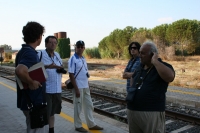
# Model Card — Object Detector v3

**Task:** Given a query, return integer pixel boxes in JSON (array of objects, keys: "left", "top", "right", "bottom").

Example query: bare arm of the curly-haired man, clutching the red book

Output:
[{"left": 15, "top": 64, "right": 42, "bottom": 90}]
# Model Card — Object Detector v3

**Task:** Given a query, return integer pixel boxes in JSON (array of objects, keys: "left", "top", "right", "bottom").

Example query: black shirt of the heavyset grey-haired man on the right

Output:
[{"left": 127, "top": 60, "right": 174, "bottom": 111}]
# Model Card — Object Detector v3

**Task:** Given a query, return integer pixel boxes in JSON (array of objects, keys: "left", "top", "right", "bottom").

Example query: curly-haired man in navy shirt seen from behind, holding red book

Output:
[{"left": 15, "top": 22, "right": 48, "bottom": 133}]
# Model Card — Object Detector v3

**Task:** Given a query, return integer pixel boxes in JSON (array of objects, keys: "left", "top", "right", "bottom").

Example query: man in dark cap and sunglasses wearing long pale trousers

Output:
[{"left": 68, "top": 40, "right": 103, "bottom": 132}]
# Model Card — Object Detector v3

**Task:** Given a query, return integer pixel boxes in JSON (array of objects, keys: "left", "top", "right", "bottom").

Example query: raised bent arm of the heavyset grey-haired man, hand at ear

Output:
[{"left": 151, "top": 53, "right": 175, "bottom": 82}]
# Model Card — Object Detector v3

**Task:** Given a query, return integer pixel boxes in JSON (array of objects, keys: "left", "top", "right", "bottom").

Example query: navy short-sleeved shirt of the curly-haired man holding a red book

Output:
[{"left": 15, "top": 44, "right": 46, "bottom": 110}]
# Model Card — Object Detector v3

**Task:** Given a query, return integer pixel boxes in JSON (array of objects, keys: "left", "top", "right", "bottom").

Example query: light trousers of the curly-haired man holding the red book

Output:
[{"left": 23, "top": 111, "right": 49, "bottom": 133}]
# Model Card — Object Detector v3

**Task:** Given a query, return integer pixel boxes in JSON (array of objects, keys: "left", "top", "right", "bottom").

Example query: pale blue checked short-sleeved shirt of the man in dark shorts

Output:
[{"left": 38, "top": 50, "right": 62, "bottom": 94}]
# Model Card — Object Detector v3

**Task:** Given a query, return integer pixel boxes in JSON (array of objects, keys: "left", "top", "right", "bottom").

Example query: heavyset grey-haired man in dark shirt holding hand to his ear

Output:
[{"left": 127, "top": 42, "right": 175, "bottom": 133}]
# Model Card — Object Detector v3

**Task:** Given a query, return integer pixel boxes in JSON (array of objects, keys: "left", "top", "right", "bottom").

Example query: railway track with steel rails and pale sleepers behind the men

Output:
[{"left": 0, "top": 67, "right": 200, "bottom": 133}]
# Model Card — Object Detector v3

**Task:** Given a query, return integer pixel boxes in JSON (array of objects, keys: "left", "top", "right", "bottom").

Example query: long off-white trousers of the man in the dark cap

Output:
[{"left": 73, "top": 88, "right": 96, "bottom": 128}]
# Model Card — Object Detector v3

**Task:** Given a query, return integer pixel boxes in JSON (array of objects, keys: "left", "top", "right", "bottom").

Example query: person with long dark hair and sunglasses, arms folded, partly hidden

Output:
[{"left": 122, "top": 42, "right": 140, "bottom": 93}]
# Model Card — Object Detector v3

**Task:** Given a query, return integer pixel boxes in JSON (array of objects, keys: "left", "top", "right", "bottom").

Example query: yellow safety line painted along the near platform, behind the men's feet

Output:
[{"left": 0, "top": 82, "right": 102, "bottom": 133}]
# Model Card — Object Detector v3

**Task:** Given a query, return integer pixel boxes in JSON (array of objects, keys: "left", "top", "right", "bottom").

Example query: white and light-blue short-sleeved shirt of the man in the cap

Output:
[{"left": 68, "top": 53, "right": 89, "bottom": 89}]
